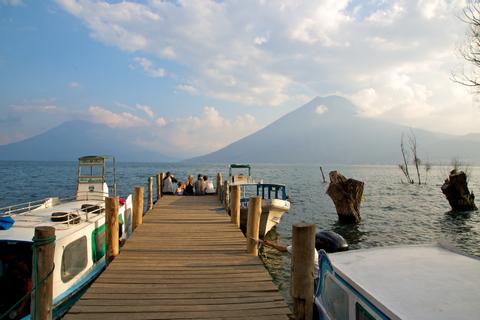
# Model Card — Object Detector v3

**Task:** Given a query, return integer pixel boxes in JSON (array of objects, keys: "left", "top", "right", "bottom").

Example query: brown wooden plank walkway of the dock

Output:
[{"left": 64, "top": 196, "right": 291, "bottom": 320}]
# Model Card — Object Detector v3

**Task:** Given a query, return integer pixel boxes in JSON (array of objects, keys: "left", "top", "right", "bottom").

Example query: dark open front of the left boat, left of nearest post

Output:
[{"left": 0, "top": 241, "right": 32, "bottom": 319}]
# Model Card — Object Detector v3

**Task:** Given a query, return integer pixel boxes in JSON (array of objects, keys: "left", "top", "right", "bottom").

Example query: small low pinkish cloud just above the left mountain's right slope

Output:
[{"left": 88, "top": 106, "right": 148, "bottom": 128}]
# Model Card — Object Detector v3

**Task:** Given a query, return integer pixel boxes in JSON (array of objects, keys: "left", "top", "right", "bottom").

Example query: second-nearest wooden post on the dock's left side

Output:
[{"left": 105, "top": 197, "right": 119, "bottom": 263}]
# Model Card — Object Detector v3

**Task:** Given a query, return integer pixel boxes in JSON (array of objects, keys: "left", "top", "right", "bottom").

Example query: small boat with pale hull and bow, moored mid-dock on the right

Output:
[{"left": 236, "top": 183, "right": 290, "bottom": 238}]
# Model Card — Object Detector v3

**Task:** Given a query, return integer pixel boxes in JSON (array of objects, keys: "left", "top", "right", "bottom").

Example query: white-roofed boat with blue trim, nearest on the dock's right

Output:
[{"left": 314, "top": 244, "right": 480, "bottom": 320}]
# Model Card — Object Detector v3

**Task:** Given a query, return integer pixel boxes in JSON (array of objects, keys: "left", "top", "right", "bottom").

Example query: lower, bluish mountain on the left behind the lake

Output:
[{"left": 0, "top": 120, "right": 174, "bottom": 162}]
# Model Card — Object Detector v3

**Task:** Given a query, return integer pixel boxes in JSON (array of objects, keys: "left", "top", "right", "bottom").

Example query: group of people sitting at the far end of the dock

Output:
[{"left": 162, "top": 172, "right": 215, "bottom": 196}]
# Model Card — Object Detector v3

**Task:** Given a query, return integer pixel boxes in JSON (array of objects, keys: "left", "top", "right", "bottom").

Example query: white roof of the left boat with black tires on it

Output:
[{"left": 0, "top": 200, "right": 104, "bottom": 242}]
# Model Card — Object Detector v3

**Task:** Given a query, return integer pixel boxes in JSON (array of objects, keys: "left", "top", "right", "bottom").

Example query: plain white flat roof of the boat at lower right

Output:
[{"left": 329, "top": 245, "right": 480, "bottom": 319}]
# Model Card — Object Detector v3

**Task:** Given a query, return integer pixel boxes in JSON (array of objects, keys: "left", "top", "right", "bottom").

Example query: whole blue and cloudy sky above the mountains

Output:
[{"left": 0, "top": 0, "right": 480, "bottom": 157}]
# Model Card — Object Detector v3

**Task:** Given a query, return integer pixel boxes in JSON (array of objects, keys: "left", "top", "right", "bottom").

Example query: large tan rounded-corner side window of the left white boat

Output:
[{"left": 62, "top": 236, "right": 88, "bottom": 282}]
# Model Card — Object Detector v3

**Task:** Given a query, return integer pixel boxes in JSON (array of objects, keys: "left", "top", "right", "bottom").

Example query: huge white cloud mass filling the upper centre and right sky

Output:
[{"left": 57, "top": 0, "right": 478, "bottom": 133}]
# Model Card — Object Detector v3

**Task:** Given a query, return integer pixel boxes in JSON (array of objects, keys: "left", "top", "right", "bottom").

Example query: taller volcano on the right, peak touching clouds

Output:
[{"left": 189, "top": 96, "right": 480, "bottom": 164}]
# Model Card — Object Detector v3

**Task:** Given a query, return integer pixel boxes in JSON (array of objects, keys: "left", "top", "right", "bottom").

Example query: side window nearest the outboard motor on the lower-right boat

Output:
[{"left": 321, "top": 274, "right": 348, "bottom": 320}]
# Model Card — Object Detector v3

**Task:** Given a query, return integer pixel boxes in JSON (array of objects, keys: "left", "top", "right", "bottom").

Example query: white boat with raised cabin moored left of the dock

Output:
[{"left": 0, "top": 156, "right": 132, "bottom": 319}]
